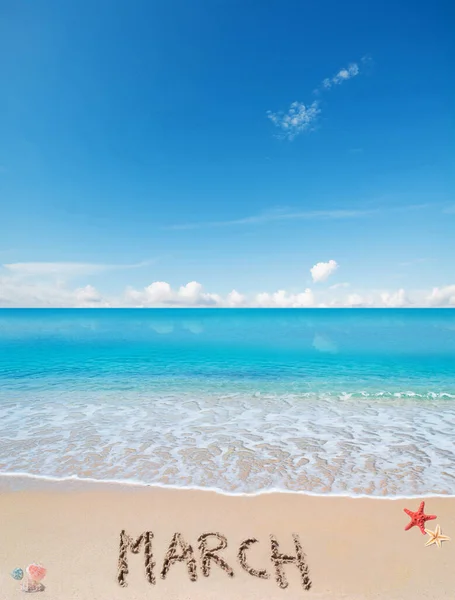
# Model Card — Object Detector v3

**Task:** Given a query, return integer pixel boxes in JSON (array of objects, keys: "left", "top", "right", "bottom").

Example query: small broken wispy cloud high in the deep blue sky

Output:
[{"left": 267, "top": 57, "right": 366, "bottom": 141}]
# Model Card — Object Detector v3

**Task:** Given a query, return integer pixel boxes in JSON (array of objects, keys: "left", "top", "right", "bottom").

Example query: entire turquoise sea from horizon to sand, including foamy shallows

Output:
[{"left": 0, "top": 309, "right": 455, "bottom": 497}]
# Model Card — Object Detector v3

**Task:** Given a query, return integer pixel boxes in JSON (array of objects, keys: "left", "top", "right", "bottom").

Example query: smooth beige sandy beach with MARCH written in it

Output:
[{"left": 0, "top": 478, "right": 455, "bottom": 600}]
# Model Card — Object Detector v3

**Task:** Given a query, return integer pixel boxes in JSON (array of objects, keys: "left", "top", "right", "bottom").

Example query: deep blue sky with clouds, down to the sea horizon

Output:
[{"left": 0, "top": 0, "right": 455, "bottom": 306}]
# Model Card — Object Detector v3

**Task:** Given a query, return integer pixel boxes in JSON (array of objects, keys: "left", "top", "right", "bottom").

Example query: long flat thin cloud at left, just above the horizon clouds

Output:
[{"left": 3, "top": 260, "right": 154, "bottom": 278}]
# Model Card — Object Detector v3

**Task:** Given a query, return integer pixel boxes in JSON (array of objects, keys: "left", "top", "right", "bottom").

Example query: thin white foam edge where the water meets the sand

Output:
[{"left": 0, "top": 472, "right": 455, "bottom": 501}]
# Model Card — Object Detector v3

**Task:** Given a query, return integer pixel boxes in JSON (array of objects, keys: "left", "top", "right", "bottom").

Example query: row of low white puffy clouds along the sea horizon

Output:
[{"left": 0, "top": 261, "right": 455, "bottom": 308}]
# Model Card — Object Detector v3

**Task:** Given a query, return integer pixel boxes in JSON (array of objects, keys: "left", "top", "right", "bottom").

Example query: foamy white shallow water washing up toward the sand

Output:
[{"left": 0, "top": 390, "right": 455, "bottom": 497}]
